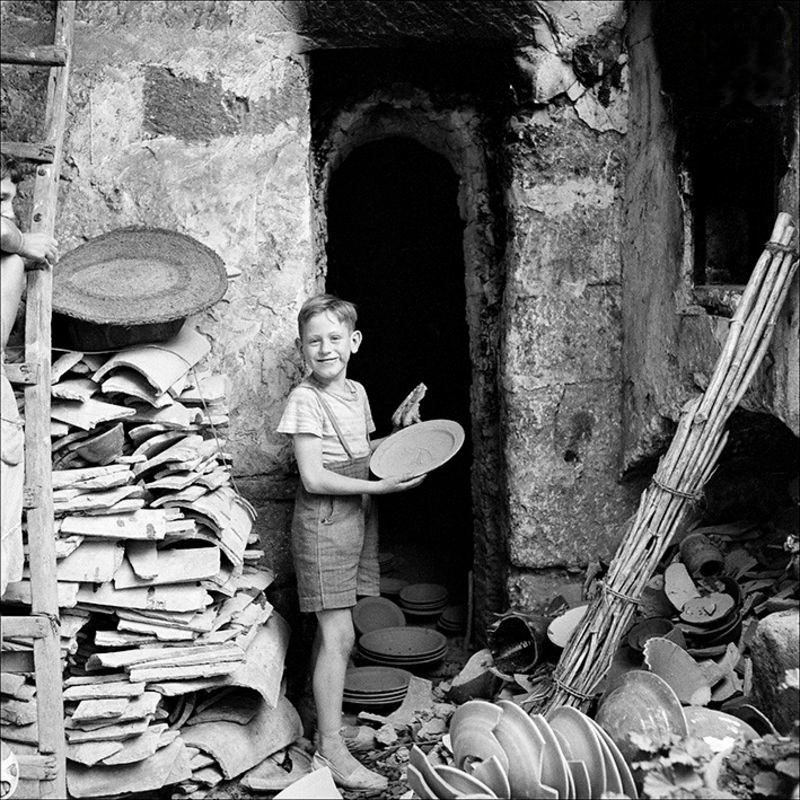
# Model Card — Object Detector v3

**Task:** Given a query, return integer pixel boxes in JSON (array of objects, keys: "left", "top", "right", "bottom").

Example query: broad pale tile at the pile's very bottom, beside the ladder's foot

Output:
[{"left": 67, "top": 738, "right": 192, "bottom": 797}]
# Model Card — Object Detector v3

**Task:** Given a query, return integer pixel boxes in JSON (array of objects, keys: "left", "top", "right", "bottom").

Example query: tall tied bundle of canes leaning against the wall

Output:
[{"left": 545, "top": 214, "right": 797, "bottom": 709}]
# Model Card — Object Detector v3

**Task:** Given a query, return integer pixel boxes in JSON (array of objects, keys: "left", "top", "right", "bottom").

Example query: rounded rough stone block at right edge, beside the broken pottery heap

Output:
[{"left": 750, "top": 610, "right": 800, "bottom": 733}]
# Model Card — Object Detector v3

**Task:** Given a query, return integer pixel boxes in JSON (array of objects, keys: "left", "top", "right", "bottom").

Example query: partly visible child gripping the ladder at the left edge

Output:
[{"left": 0, "top": 154, "right": 58, "bottom": 595}]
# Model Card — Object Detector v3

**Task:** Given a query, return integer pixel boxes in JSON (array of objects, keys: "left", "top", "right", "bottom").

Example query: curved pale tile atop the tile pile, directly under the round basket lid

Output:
[{"left": 92, "top": 325, "right": 211, "bottom": 394}]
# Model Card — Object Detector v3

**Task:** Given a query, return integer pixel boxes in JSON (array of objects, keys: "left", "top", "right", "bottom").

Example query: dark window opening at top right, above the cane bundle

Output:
[{"left": 654, "top": 0, "right": 798, "bottom": 285}]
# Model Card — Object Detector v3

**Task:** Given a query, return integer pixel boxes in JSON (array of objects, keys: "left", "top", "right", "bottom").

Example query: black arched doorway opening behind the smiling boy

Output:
[{"left": 327, "top": 137, "right": 472, "bottom": 602}]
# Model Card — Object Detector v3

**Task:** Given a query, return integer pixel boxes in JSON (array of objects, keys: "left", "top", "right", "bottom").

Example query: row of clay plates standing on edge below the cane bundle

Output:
[{"left": 440, "top": 700, "right": 638, "bottom": 800}]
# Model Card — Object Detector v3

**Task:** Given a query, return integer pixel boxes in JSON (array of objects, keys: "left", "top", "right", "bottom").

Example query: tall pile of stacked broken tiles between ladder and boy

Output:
[{"left": 3, "top": 327, "right": 300, "bottom": 797}]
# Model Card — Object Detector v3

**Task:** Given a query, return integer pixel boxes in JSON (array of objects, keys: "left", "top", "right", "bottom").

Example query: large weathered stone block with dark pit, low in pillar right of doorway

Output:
[{"left": 506, "top": 381, "right": 638, "bottom": 568}]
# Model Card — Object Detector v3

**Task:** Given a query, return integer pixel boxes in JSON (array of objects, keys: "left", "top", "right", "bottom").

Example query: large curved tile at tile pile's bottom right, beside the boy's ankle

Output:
[{"left": 181, "top": 697, "right": 303, "bottom": 779}]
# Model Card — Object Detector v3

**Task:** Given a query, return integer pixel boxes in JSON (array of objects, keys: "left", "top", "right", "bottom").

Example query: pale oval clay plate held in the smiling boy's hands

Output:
[{"left": 369, "top": 419, "right": 464, "bottom": 478}]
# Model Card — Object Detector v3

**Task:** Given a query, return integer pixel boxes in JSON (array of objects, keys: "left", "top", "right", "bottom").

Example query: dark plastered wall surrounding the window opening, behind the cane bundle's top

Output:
[{"left": 622, "top": 2, "right": 800, "bottom": 467}]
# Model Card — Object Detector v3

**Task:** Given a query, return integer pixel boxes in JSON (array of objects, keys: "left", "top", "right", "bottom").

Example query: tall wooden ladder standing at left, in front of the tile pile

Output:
[{"left": 0, "top": 0, "right": 75, "bottom": 798}]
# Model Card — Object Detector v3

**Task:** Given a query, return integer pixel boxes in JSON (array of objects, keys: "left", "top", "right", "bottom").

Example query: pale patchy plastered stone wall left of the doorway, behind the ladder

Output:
[{"left": 2, "top": 0, "right": 313, "bottom": 588}]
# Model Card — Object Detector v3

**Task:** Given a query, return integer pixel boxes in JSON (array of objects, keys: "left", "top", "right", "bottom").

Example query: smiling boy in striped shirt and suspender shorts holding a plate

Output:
[{"left": 278, "top": 294, "right": 424, "bottom": 791}]
